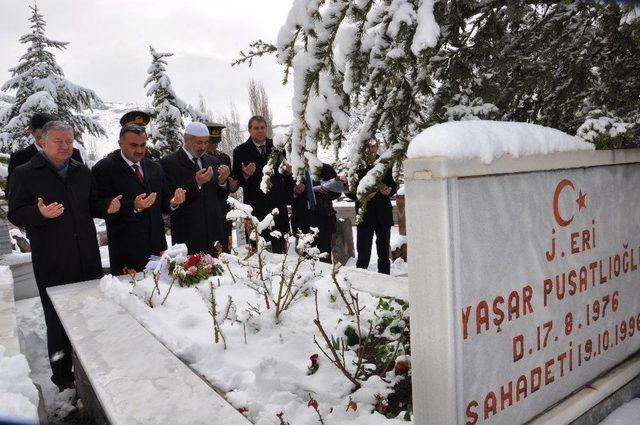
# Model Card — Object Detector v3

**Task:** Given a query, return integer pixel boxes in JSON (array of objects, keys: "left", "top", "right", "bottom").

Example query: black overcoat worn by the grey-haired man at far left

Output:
[{"left": 8, "top": 155, "right": 105, "bottom": 287}]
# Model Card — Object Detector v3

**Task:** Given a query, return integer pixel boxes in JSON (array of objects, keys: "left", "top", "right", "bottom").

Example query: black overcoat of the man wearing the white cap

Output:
[{"left": 160, "top": 148, "right": 228, "bottom": 255}]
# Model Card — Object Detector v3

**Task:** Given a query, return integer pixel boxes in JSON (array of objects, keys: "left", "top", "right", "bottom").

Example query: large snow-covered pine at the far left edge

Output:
[{"left": 0, "top": 4, "right": 106, "bottom": 152}]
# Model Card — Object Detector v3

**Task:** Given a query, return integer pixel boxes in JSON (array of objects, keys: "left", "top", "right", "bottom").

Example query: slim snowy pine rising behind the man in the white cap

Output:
[{"left": 144, "top": 46, "right": 207, "bottom": 155}]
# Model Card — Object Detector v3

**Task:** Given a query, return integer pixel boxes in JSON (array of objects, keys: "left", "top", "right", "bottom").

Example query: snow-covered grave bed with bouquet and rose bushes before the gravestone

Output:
[{"left": 49, "top": 230, "right": 411, "bottom": 424}]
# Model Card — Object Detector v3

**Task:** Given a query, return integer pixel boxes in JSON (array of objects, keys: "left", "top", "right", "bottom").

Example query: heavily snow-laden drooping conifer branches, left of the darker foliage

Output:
[{"left": 277, "top": 0, "right": 439, "bottom": 215}]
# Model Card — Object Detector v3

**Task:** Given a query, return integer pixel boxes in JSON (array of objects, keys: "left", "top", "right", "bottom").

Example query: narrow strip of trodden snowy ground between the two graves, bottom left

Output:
[{"left": 15, "top": 297, "right": 77, "bottom": 425}]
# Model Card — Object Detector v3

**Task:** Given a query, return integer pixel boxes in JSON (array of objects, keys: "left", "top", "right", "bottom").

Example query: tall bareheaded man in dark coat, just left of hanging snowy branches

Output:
[{"left": 232, "top": 116, "right": 293, "bottom": 253}]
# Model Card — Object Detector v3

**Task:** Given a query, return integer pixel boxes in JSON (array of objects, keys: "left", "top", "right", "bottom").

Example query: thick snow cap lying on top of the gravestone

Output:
[{"left": 407, "top": 120, "right": 595, "bottom": 164}]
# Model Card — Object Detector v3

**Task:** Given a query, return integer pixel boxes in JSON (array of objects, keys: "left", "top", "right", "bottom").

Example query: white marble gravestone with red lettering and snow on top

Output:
[{"left": 405, "top": 121, "right": 640, "bottom": 424}]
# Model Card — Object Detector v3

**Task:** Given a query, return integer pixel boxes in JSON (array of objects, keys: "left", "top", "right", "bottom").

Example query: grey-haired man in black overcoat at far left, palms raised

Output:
[{"left": 8, "top": 121, "right": 120, "bottom": 390}]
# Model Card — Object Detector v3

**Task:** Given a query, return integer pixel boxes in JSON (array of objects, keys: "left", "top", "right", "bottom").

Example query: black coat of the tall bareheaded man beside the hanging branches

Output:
[{"left": 231, "top": 139, "right": 294, "bottom": 234}]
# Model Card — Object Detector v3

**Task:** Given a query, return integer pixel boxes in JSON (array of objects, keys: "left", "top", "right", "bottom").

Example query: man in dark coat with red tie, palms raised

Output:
[{"left": 91, "top": 124, "right": 185, "bottom": 275}]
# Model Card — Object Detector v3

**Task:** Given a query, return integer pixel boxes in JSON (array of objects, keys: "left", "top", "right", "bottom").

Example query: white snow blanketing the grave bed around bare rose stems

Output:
[{"left": 100, "top": 245, "right": 410, "bottom": 425}]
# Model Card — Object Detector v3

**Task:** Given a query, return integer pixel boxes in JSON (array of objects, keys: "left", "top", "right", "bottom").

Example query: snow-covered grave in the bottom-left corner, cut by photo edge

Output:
[{"left": 0, "top": 266, "right": 39, "bottom": 423}]
